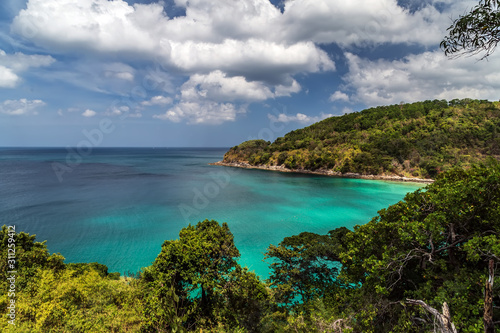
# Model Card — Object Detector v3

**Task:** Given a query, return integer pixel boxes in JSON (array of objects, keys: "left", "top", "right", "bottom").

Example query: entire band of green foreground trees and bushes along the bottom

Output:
[{"left": 0, "top": 160, "right": 500, "bottom": 333}]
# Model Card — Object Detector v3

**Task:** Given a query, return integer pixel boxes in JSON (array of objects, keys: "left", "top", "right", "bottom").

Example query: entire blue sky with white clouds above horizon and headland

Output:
[{"left": 0, "top": 0, "right": 500, "bottom": 147}]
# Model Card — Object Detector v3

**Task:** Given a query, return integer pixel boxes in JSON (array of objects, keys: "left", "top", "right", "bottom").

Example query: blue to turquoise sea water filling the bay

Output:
[{"left": 0, "top": 148, "right": 422, "bottom": 278}]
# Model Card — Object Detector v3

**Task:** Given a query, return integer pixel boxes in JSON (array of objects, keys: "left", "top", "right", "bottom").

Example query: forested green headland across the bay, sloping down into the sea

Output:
[{"left": 223, "top": 99, "right": 500, "bottom": 178}]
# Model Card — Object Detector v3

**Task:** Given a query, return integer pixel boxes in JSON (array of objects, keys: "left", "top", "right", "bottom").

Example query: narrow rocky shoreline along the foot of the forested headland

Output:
[{"left": 209, "top": 161, "right": 434, "bottom": 184}]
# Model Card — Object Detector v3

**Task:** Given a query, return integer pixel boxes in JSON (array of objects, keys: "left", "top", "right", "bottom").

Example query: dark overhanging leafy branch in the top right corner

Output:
[{"left": 441, "top": 0, "right": 500, "bottom": 59}]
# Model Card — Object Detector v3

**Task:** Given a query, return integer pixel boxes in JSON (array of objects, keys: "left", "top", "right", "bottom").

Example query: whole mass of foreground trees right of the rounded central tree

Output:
[{"left": 267, "top": 161, "right": 500, "bottom": 333}]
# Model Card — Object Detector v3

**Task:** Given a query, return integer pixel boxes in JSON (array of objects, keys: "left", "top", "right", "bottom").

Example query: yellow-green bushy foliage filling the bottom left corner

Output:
[{"left": 0, "top": 226, "right": 142, "bottom": 333}]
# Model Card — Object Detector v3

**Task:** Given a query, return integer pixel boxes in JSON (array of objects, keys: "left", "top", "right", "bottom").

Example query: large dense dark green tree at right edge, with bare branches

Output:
[{"left": 340, "top": 161, "right": 500, "bottom": 332}]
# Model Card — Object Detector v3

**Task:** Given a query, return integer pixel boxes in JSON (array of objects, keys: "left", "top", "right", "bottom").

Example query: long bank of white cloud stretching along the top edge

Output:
[{"left": 6, "top": 0, "right": 464, "bottom": 82}]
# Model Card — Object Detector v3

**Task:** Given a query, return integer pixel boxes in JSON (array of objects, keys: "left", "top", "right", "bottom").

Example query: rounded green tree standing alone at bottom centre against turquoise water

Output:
[{"left": 141, "top": 220, "right": 268, "bottom": 332}]
